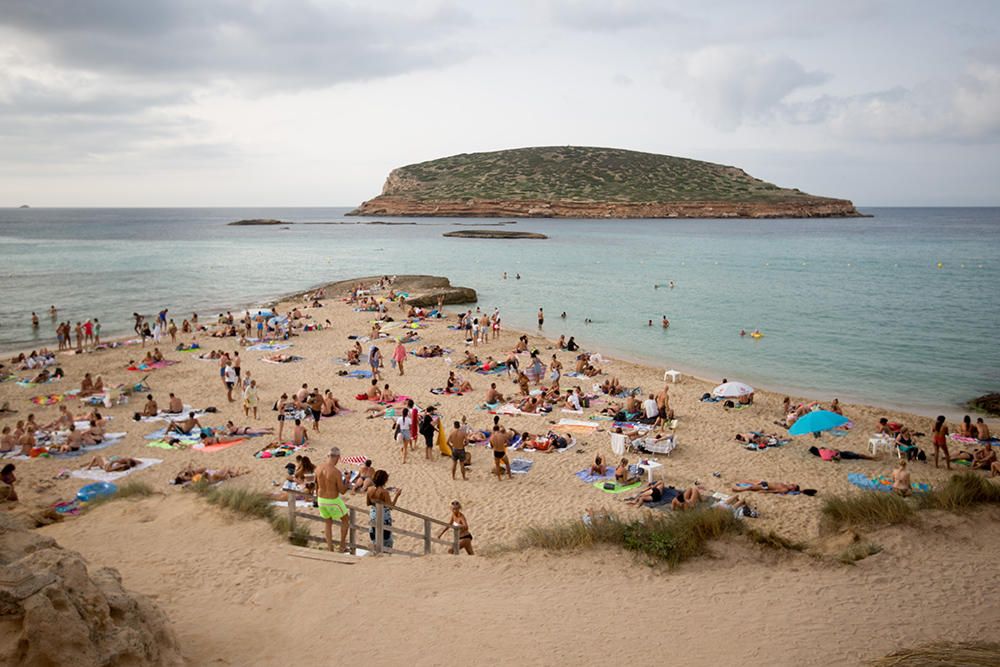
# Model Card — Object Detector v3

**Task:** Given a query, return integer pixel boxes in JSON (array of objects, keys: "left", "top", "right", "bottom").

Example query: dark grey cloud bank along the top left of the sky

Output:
[{"left": 0, "top": 0, "right": 468, "bottom": 88}]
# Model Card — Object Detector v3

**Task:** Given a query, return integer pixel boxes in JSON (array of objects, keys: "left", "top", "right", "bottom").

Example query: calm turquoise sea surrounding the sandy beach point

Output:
[{"left": 0, "top": 208, "right": 1000, "bottom": 411}]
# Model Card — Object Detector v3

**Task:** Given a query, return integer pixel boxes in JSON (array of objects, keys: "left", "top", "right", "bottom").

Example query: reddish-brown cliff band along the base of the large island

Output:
[{"left": 349, "top": 196, "right": 861, "bottom": 218}]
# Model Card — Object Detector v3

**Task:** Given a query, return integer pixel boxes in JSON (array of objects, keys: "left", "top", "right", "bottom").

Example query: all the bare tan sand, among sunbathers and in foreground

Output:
[{"left": 0, "top": 276, "right": 1000, "bottom": 664}]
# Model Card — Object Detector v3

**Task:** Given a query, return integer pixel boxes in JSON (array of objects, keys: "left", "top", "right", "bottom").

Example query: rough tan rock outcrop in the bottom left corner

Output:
[{"left": 0, "top": 514, "right": 184, "bottom": 667}]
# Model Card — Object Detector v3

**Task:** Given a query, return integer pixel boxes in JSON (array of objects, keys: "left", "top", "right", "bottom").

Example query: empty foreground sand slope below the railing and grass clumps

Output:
[{"left": 43, "top": 496, "right": 1000, "bottom": 665}]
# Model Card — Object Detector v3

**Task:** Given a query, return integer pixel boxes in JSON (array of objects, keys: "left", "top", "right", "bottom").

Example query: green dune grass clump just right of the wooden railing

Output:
[{"left": 518, "top": 509, "right": 743, "bottom": 567}]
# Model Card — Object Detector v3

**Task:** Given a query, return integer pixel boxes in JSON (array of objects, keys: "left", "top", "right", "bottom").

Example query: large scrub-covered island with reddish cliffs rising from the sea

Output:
[{"left": 348, "top": 146, "right": 861, "bottom": 218}]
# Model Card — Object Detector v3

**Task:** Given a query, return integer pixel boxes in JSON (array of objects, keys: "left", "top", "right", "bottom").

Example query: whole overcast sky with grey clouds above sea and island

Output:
[{"left": 0, "top": 0, "right": 1000, "bottom": 206}]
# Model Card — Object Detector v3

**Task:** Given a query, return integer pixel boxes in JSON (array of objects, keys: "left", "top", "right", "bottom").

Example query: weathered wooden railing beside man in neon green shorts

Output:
[{"left": 284, "top": 489, "right": 460, "bottom": 556}]
